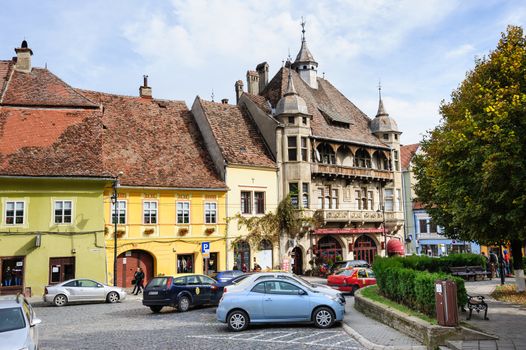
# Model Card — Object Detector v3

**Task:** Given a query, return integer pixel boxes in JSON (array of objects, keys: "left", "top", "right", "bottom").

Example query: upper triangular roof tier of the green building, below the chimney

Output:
[{"left": 0, "top": 68, "right": 99, "bottom": 108}]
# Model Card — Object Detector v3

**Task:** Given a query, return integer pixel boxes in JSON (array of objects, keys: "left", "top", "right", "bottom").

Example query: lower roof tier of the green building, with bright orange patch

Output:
[{"left": 0, "top": 106, "right": 104, "bottom": 176}]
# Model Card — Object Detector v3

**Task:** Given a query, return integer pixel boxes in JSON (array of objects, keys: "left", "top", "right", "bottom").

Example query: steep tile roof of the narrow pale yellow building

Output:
[{"left": 198, "top": 98, "right": 276, "bottom": 167}]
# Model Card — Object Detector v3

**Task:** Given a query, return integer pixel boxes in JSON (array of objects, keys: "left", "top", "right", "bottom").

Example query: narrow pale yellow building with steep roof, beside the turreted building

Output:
[{"left": 192, "top": 97, "right": 280, "bottom": 270}]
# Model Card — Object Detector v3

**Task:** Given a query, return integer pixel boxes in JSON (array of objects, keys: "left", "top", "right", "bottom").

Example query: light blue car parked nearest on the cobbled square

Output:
[{"left": 216, "top": 278, "right": 345, "bottom": 332}]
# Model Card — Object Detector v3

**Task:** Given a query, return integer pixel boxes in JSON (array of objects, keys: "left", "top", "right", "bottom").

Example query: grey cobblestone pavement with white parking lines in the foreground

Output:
[{"left": 35, "top": 296, "right": 364, "bottom": 350}]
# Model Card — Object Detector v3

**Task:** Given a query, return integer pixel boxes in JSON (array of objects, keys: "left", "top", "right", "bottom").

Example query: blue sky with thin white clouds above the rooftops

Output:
[{"left": 0, "top": 0, "right": 526, "bottom": 144}]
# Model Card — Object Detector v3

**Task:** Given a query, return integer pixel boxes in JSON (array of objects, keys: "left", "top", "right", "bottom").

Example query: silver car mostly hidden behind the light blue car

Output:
[{"left": 217, "top": 272, "right": 345, "bottom": 304}]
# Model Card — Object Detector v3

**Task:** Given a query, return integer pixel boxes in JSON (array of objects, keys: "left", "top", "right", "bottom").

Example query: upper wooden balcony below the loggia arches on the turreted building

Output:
[{"left": 311, "top": 163, "right": 394, "bottom": 182}]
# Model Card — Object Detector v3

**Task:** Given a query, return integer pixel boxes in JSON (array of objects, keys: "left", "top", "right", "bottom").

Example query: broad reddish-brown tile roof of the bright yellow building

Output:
[{"left": 78, "top": 90, "right": 226, "bottom": 189}]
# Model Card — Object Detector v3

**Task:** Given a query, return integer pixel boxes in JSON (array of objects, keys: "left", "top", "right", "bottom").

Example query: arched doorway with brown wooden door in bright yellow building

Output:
[{"left": 117, "top": 249, "right": 154, "bottom": 288}]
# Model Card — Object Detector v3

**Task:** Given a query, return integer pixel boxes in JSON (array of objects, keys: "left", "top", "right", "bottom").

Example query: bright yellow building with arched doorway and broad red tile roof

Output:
[{"left": 81, "top": 88, "right": 227, "bottom": 287}]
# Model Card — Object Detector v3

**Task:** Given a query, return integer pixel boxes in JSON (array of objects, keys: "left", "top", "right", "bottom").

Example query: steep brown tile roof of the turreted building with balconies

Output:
[{"left": 261, "top": 68, "right": 387, "bottom": 148}]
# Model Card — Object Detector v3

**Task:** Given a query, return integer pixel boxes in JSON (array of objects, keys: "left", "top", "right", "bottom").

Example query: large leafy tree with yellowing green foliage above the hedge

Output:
[{"left": 414, "top": 26, "right": 526, "bottom": 291}]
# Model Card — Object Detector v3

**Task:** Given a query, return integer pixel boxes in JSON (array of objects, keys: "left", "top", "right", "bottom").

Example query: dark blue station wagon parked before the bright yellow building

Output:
[{"left": 142, "top": 274, "right": 219, "bottom": 313}]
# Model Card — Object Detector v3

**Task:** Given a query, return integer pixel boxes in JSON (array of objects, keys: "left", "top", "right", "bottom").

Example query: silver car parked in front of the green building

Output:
[{"left": 44, "top": 278, "right": 126, "bottom": 306}]
